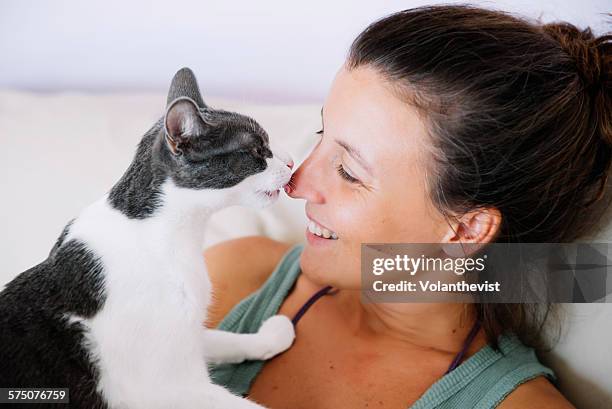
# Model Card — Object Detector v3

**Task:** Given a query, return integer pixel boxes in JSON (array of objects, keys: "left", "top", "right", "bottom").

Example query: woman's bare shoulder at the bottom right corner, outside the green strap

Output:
[{"left": 498, "top": 376, "right": 576, "bottom": 409}]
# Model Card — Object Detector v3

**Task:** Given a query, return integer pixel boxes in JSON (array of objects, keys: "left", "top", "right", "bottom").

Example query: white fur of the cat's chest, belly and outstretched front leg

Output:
[{"left": 65, "top": 182, "right": 295, "bottom": 409}]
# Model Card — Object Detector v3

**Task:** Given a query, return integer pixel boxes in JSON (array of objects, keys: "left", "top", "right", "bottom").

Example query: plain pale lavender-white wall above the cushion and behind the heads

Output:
[{"left": 0, "top": 0, "right": 612, "bottom": 102}]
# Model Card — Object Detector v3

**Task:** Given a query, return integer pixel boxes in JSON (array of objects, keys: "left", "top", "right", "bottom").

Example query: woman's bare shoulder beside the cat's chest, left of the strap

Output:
[{"left": 204, "top": 236, "right": 291, "bottom": 328}]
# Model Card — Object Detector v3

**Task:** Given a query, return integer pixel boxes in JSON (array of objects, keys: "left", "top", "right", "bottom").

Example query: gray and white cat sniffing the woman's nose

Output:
[{"left": 0, "top": 68, "right": 295, "bottom": 409}]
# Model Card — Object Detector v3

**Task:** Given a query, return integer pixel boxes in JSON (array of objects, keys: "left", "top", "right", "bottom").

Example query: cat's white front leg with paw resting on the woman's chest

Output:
[{"left": 204, "top": 315, "right": 295, "bottom": 364}]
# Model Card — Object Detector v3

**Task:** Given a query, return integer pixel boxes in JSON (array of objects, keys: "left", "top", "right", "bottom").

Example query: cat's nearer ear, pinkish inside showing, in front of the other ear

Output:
[{"left": 164, "top": 97, "right": 206, "bottom": 155}]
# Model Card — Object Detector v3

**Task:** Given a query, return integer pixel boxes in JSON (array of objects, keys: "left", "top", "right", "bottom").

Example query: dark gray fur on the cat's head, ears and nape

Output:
[{"left": 109, "top": 68, "right": 272, "bottom": 218}]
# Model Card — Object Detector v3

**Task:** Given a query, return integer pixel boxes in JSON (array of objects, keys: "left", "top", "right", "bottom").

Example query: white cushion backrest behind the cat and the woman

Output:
[{"left": 0, "top": 91, "right": 612, "bottom": 409}]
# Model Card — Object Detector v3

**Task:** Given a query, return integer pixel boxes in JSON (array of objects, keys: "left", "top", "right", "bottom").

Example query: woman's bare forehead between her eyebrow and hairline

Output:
[{"left": 322, "top": 67, "right": 427, "bottom": 166}]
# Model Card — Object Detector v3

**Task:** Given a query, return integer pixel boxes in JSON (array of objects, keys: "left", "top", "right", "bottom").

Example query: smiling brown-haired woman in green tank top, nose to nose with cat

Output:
[{"left": 206, "top": 6, "right": 612, "bottom": 409}]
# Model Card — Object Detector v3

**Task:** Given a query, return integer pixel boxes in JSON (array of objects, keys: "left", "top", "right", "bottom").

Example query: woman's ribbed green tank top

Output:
[{"left": 209, "top": 244, "right": 556, "bottom": 409}]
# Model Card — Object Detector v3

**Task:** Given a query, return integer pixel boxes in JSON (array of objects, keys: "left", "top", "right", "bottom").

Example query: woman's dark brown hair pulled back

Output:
[{"left": 347, "top": 5, "right": 612, "bottom": 347}]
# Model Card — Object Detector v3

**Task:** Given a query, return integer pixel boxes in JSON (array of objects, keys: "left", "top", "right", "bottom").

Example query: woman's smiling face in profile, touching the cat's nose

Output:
[{"left": 289, "top": 67, "right": 449, "bottom": 289}]
